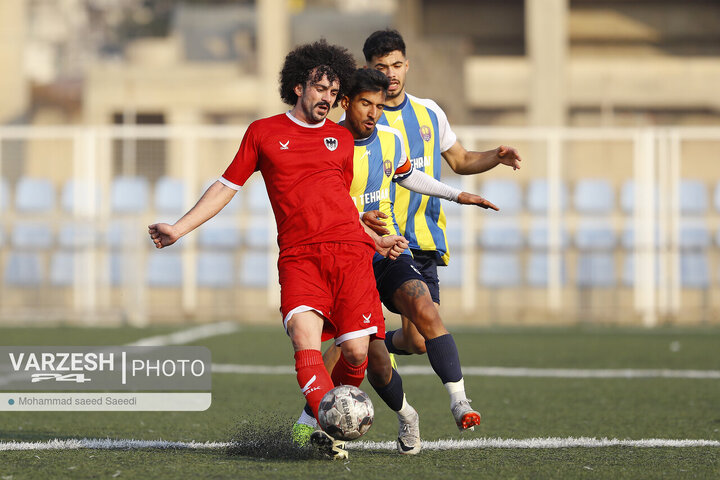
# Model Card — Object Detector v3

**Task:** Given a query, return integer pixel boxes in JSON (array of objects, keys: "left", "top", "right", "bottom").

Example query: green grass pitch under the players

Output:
[{"left": 0, "top": 326, "right": 720, "bottom": 480}]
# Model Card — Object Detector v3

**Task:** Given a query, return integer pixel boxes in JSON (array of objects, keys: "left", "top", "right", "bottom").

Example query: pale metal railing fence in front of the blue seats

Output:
[{"left": 0, "top": 126, "right": 720, "bottom": 326}]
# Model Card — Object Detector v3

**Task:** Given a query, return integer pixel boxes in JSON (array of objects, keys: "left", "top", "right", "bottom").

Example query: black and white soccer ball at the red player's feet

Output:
[{"left": 318, "top": 385, "right": 375, "bottom": 440}]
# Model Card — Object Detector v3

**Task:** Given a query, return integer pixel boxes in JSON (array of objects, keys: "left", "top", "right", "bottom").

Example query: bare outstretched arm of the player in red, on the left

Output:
[{"left": 148, "top": 181, "right": 237, "bottom": 248}]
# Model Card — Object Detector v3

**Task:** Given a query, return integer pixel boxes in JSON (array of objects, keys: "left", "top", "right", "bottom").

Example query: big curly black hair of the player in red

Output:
[{"left": 280, "top": 38, "right": 356, "bottom": 107}]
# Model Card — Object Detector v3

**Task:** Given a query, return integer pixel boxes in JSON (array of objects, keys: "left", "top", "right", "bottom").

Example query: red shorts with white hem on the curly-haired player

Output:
[{"left": 278, "top": 242, "right": 385, "bottom": 345}]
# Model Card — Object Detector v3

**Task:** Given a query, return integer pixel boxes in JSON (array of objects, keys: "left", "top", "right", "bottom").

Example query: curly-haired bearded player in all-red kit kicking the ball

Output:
[{"left": 148, "top": 40, "right": 408, "bottom": 457}]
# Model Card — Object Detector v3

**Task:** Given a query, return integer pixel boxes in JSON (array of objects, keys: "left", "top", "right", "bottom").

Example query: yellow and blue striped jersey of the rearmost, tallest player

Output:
[{"left": 380, "top": 93, "right": 457, "bottom": 265}]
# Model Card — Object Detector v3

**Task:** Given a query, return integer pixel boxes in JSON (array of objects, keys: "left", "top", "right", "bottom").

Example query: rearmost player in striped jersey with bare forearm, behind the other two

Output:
[{"left": 363, "top": 30, "right": 521, "bottom": 431}]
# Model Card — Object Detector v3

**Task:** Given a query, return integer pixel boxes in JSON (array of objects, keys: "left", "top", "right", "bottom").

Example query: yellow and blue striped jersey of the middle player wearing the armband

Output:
[{"left": 350, "top": 125, "right": 412, "bottom": 253}]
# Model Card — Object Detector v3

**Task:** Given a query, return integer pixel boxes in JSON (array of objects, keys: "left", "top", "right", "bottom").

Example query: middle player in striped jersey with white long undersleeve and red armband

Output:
[{"left": 340, "top": 69, "right": 497, "bottom": 436}]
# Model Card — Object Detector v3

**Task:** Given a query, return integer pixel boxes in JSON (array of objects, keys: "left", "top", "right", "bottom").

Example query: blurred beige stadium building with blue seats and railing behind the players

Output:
[{"left": 0, "top": 0, "right": 720, "bottom": 325}]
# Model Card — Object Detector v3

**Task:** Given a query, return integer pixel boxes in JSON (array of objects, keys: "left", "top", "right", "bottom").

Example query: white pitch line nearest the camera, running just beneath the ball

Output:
[{"left": 0, "top": 437, "right": 720, "bottom": 451}]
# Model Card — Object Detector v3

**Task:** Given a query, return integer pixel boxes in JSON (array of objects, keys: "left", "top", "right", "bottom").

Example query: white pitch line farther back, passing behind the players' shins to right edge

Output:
[{"left": 212, "top": 364, "right": 720, "bottom": 379}]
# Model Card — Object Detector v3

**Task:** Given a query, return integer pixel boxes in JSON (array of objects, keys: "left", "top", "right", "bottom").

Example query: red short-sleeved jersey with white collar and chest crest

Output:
[{"left": 220, "top": 112, "right": 374, "bottom": 251}]
